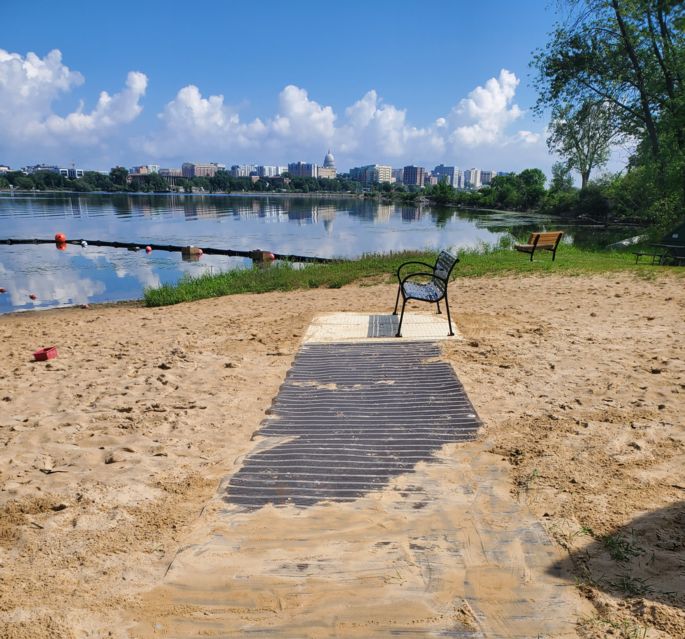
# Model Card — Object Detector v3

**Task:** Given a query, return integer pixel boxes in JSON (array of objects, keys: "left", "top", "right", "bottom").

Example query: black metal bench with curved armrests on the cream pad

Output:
[{"left": 392, "top": 251, "right": 459, "bottom": 337}]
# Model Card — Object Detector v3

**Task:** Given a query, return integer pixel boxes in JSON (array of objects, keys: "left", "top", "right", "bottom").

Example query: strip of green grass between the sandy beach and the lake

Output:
[{"left": 145, "top": 245, "right": 685, "bottom": 306}]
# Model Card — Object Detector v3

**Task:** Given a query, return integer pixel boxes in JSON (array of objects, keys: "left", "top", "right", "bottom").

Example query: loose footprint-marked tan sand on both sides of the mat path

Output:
[{"left": 0, "top": 275, "right": 685, "bottom": 637}]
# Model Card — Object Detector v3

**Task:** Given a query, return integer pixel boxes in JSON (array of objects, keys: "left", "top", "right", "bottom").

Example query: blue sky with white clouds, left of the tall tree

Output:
[{"left": 0, "top": 0, "right": 584, "bottom": 174}]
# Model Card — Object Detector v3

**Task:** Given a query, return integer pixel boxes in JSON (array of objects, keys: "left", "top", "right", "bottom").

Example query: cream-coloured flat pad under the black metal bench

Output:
[{"left": 303, "top": 312, "right": 462, "bottom": 343}]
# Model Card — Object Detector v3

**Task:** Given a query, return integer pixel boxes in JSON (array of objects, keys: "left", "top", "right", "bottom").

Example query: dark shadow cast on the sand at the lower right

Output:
[{"left": 548, "top": 501, "right": 685, "bottom": 612}]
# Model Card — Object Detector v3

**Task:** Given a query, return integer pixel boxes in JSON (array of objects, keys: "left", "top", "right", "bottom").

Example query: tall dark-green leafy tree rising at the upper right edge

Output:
[{"left": 534, "top": 0, "right": 685, "bottom": 220}]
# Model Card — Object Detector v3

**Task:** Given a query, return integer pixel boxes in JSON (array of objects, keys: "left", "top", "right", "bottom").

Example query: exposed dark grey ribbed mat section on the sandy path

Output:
[{"left": 224, "top": 341, "right": 480, "bottom": 509}]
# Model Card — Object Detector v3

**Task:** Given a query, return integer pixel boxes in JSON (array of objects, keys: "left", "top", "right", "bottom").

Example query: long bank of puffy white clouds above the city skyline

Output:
[{"left": 144, "top": 69, "right": 541, "bottom": 168}]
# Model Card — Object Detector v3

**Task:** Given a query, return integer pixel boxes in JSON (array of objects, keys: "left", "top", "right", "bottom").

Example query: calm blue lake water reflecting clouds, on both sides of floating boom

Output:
[{"left": 0, "top": 194, "right": 620, "bottom": 313}]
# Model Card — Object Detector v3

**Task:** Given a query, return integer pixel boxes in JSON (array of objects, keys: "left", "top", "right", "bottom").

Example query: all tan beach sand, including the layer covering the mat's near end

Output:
[{"left": 0, "top": 274, "right": 685, "bottom": 638}]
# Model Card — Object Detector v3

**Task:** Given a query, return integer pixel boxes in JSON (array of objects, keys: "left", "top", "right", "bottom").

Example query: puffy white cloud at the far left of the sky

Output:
[{"left": 0, "top": 49, "right": 147, "bottom": 146}]
